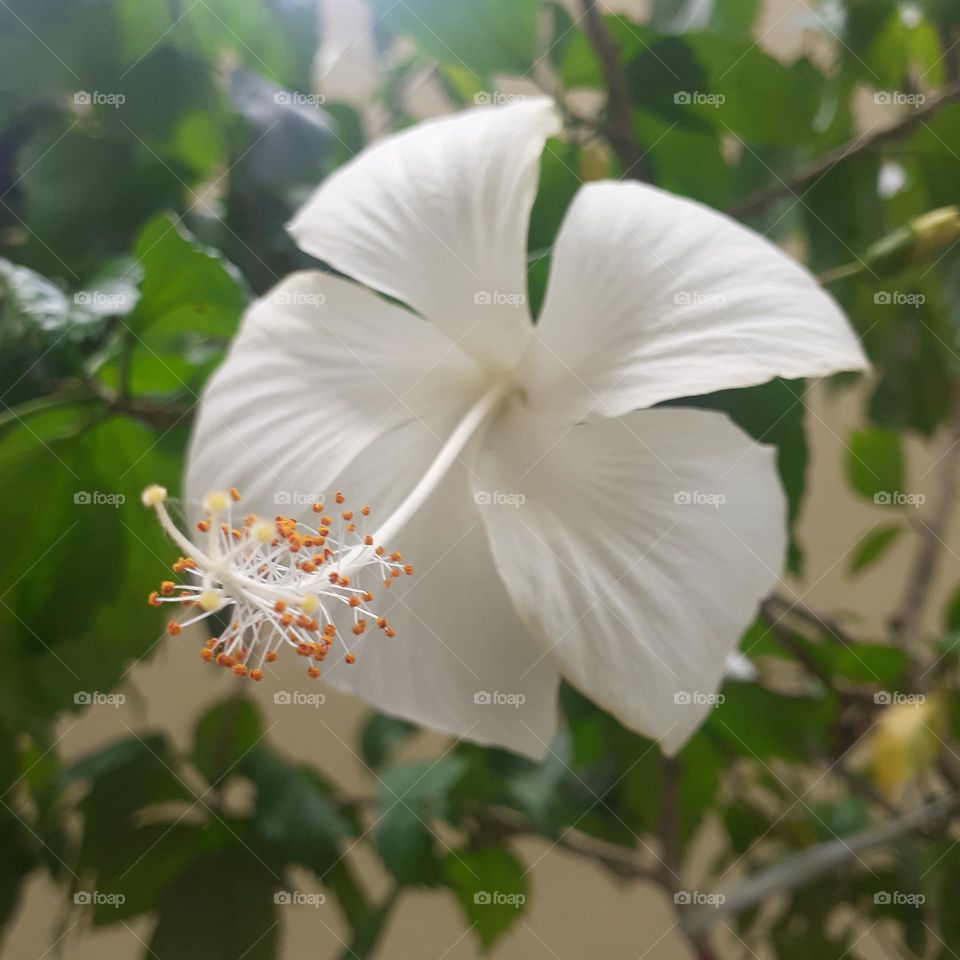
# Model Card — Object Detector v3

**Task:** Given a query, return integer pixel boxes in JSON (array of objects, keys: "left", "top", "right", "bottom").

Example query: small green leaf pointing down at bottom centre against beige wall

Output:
[{"left": 443, "top": 847, "right": 527, "bottom": 950}]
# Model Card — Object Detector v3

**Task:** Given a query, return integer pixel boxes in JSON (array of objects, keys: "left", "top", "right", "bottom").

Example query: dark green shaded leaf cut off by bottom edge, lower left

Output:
[{"left": 148, "top": 849, "right": 279, "bottom": 960}]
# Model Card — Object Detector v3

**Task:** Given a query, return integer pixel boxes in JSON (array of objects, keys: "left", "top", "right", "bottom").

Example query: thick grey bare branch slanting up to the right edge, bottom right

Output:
[{"left": 682, "top": 795, "right": 960, "bottom": 936}]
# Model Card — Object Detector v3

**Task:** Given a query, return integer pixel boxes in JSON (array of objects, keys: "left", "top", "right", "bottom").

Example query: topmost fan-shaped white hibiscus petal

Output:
[{"left": 289, "top": 98, "right": 560, "bottom": 365}]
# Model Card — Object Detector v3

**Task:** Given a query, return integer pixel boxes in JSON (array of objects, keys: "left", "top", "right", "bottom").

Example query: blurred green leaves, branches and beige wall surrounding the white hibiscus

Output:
[{"left": 0, "top": 0, "right": 960, "bottom": 960}]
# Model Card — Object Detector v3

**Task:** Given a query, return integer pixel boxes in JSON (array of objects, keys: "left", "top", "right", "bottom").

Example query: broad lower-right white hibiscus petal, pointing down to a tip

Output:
[{"left": 478, "top": 409, "right": 786, "bottom": 753}]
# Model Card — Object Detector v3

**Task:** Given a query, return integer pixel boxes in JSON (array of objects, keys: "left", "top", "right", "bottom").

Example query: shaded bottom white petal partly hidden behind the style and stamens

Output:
[{"left": 316, "top": 414, "right": 559, "bottom": 759}]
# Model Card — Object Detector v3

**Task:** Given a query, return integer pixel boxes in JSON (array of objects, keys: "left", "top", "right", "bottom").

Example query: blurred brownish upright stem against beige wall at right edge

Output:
[{"left": 890, "top": 399, "right": 960, "bottom": 647}]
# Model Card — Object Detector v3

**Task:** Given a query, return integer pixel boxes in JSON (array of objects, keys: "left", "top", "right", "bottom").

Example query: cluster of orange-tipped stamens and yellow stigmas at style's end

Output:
[{"left": 142, "top": 486, "right": 413, "bottom": 680}]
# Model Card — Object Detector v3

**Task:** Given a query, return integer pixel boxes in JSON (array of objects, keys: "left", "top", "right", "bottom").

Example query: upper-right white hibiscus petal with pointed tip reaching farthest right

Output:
[{"left": 522, "top": 183, "right": 866, "bottom": 423}]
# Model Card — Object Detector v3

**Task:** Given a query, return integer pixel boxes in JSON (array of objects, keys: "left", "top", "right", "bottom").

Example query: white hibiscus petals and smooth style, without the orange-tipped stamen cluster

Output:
[{"left": 186, "top": 99, "right": 866, "bottom": 757}]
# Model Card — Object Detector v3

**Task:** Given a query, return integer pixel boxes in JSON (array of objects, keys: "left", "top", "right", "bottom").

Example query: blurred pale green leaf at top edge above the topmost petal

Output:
[{"left": 373, "top": 0, "right": 537, "bottom": 75}]
